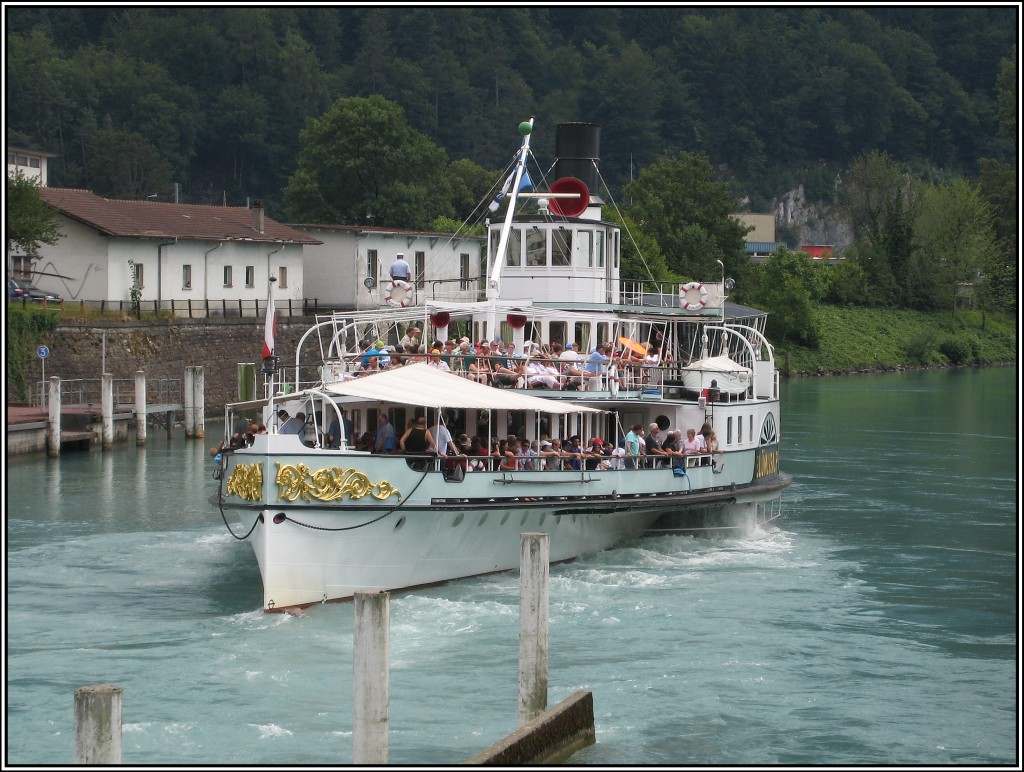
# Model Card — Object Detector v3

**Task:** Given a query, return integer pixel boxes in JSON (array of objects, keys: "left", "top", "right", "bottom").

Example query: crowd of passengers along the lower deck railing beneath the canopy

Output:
[{"left": 395, "top": 416, "right": 719, "bottom": 472}]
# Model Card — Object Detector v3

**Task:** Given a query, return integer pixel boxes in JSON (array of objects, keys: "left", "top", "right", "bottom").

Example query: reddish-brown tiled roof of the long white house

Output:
[{"left": 41, "top": 187, "right": 323, "bottom": 244}]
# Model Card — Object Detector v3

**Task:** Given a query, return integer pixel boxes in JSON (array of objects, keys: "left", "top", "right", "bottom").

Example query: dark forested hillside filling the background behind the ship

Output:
[{"left": 5, "top": 5, "right": 1019, "bottom": 217}]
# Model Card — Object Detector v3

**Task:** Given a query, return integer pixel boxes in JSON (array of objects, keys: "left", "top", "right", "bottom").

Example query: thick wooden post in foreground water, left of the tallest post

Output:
[{"left": 352, "top": 591, "right": 390, "bottom": 764}]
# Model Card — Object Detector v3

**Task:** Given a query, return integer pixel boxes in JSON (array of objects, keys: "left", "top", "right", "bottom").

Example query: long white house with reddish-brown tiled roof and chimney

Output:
[{"left": 29, "top": 187, "right": 321, "bottom": 312}]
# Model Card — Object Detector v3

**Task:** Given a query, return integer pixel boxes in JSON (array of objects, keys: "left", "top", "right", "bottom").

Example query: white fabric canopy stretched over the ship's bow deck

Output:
[{"left": 324, "top": 362, "right": 604, "bottom": 415}]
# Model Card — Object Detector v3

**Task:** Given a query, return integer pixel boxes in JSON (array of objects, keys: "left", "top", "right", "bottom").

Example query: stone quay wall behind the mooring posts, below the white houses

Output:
[{"left": 7, "top": 316, "right": 318, "bottom": 419}]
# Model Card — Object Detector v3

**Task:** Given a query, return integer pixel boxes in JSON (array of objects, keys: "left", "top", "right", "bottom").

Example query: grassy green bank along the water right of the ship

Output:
[{"left": 776, "top": 306, "right": 1017, "bottom": 374}]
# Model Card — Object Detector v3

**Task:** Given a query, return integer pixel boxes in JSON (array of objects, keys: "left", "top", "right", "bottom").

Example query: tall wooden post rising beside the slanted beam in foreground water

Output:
[{"left": 519, "top": 533, "right": 551, "bottom": 726}]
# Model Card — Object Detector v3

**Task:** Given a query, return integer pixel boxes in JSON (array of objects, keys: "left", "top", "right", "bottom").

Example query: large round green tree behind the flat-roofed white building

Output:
[{"left": 285, "top": 96, "right": 452, "bottom": 228}]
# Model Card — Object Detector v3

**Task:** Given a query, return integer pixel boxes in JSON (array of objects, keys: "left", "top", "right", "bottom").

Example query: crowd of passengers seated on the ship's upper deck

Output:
[{"left": 345, "top": 327, "right": 671, "bottom": 390}]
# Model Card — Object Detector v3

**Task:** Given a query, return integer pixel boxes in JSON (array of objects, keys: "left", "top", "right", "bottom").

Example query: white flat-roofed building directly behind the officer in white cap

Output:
[{"left": 292, "top": 224, "right": 486, "bottom": 310}]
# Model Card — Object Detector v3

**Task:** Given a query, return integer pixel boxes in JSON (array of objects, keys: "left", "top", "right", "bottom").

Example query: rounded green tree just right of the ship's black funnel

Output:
[{"left": 625, "top": 153, "right": 746, "bottom": 280}]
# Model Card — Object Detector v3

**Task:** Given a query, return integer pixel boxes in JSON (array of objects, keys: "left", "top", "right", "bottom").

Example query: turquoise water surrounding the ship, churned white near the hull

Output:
[{"left": 5, "top": 369, "right": 1019, "bottom": 766}]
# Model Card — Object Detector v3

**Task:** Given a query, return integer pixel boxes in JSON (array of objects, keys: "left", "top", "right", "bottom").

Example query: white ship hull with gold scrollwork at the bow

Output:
[{"left": 221, "top": 442, "right": 787, "bottom": 611}]
